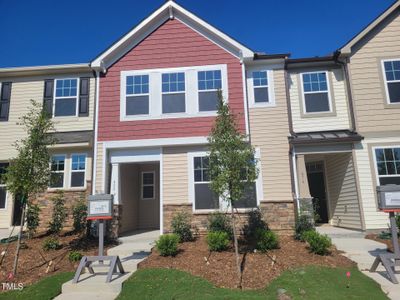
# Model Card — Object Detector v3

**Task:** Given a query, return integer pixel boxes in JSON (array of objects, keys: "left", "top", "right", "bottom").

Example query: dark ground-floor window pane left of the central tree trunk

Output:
[{"left": 193, "top": 157, "right": 219, "bottom": 209}]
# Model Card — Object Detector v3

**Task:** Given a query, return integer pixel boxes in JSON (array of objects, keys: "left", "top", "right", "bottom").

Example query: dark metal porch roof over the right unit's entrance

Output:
[{"left": 289, "top": 130, "right": 364, "bottom": 145}]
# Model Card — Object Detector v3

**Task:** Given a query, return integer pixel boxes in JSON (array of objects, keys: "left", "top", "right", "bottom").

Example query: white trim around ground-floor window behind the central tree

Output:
[{"left": 187, "top": 148, "right": 263, "bottom": 214}]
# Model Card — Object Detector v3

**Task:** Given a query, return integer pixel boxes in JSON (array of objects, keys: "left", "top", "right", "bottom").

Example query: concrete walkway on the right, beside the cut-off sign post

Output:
[{"left": 317, "top": 226, "right": 400, "bottom": 300}]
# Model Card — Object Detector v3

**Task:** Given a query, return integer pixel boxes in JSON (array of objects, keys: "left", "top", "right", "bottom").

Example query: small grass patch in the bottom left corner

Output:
[{"left": 0, "top": 272, "right": 74, "bottom": 300}]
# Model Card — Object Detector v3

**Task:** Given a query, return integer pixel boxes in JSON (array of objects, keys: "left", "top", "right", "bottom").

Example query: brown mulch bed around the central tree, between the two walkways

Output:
[{"left": 139, "top": 236, "right": 355, "bottom": 289}]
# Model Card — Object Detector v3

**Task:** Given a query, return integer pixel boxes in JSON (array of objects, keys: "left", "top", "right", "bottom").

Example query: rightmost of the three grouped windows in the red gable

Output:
[{"left": 197, "top": 70, "right": 222, "bottom": 111}]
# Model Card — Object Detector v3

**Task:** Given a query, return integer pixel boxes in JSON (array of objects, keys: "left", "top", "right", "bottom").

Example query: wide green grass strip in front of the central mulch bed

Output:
[{"left": 118, "top": 266, "right": 388, "bottom": 300}]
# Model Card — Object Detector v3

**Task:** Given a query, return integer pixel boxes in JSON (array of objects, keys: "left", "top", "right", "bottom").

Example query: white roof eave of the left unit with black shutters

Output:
[{"left": 0, "top": 64, "right": 92, "bottom": 77}]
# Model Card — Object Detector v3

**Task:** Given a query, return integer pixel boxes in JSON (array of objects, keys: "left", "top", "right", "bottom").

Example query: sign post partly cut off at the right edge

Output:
[{"left": 370, "top": 184, "right": 400, "bottom": 284}]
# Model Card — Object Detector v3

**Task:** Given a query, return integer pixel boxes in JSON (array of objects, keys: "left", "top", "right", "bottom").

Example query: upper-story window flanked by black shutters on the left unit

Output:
[{"left": 54, "top": 78, "right": 78, "bottom": 117}]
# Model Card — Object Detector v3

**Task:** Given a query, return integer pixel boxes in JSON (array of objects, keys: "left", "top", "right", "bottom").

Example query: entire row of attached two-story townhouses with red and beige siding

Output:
[{"left": 0, "top": 1, "right": 400, "bottom": 235}]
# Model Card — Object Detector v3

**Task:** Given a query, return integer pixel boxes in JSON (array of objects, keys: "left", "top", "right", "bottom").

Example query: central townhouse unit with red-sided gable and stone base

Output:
[{"left": 91, "top": 1, "right": 294, "bottom": 235}]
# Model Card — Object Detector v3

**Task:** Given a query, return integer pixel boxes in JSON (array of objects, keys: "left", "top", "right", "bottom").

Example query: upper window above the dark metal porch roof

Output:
[{"left": 301, "top": 71, "right": 331, "bottom": 113}]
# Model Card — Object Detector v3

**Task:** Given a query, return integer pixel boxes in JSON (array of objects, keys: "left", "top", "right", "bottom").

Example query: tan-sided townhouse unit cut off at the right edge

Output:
[{"left": 339, "top": 1, "right": 400, "bottom": 230}]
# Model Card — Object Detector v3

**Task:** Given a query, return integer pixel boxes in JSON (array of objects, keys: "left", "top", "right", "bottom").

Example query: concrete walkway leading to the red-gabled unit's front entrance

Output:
[{"left": 55, "top": 230, "right": 160, "bottom": 300}]
